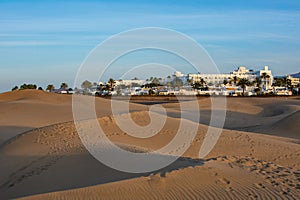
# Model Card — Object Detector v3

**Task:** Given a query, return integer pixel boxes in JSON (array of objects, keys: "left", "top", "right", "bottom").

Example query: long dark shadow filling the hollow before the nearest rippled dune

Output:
[{"left": 0, "top": 152, "right": 204, "bottom": 199}]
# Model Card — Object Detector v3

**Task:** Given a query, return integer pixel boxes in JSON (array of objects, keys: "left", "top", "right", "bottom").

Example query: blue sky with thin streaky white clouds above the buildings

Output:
[{"left": 0, "top": 0, "right": 300, "bottom": 92}]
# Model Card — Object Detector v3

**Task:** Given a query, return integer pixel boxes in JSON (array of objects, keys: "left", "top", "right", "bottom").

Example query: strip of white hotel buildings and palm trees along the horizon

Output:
[{"left": 12, "top": 66, "right": 300, "bottom": 96}]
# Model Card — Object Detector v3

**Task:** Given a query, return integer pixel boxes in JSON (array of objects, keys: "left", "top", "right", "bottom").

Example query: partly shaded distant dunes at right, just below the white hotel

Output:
[{"left": 164, "top": 98, "right": 300, "bottom": 139}]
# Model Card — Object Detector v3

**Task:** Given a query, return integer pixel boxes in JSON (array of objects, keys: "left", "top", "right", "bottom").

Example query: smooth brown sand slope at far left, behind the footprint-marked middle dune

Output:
[{"left": 0, "top": 90, "right": 147, "bottom": 145}]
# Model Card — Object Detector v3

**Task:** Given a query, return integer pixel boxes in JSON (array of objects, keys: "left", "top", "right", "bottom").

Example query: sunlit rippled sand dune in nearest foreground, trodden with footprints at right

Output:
[{"left": 19, "top": 158, "right": 299, "bottom": 199}]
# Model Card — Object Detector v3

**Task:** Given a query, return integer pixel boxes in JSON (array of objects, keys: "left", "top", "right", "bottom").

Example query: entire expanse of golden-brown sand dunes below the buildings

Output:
[{"left": 0, "top": 90, "right": 300, "bottom": 199}]
